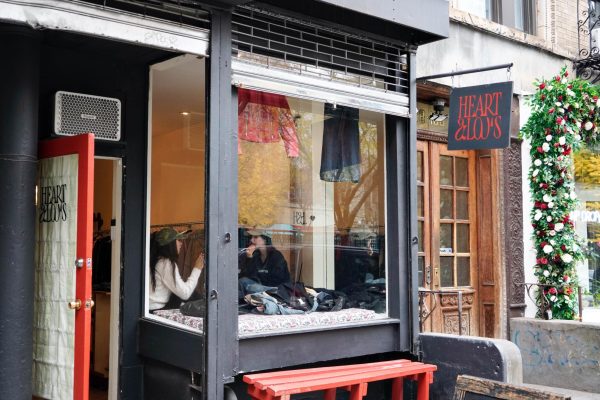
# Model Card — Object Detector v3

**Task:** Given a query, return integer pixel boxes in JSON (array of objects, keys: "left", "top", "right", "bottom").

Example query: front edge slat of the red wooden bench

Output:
[{"left": 265, "top": 363, "right": 437, "bottom": 396}]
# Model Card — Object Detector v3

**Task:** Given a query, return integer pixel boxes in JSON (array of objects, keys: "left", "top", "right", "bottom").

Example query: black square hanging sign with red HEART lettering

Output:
[{"left": 448, "top": 82, "right": 513, "bottom": 150}]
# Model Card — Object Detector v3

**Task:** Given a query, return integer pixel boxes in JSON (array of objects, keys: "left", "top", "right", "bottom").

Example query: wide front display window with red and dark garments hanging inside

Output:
[{"left": 238, "top": 88, "right": 387, "bottom": 337}]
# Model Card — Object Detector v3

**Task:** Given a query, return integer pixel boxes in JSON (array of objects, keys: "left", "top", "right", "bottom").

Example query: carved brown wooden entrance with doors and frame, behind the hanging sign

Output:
[{"left": 417, "top": 82, "right": 518, "bottom": 337}]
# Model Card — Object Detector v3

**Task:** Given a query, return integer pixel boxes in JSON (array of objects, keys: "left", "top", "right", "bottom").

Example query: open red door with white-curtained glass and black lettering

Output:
[{"left": 33, "top": 134, "right": 94, "bottom": 400}]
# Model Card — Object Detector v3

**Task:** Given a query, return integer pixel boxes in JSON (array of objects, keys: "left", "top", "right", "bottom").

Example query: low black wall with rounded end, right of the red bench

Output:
[{"left": 419, "top": 333, "right": 523, "bottom": 400}]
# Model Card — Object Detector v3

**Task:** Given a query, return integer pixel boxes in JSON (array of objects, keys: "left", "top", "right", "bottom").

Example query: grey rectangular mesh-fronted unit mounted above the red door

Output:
[{"left": 54, "top": 91, "right": 121, "bottom": 141}]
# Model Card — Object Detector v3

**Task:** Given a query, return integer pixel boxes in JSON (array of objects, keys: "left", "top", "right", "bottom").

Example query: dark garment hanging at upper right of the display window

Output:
[{"left": 320, "top": 103, "right": 360, "bottom": 183}]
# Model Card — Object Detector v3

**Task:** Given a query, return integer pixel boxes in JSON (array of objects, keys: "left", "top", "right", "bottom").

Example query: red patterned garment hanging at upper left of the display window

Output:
[{"left": 238, "top": 89, "right": 300, "bottom": 157}]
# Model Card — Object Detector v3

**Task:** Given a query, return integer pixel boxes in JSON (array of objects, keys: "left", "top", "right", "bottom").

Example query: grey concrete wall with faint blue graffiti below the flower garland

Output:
[{"left": 510, "top": 318, "right": 600, "bottom": 398}]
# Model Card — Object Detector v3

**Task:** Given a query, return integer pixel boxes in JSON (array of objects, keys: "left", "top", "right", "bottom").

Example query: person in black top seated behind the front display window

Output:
[{"left": 238, "top": 229, "right": 290, "bottom": 287}]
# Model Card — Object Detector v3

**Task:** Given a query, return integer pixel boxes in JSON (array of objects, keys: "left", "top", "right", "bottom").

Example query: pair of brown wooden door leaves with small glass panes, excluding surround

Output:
[{"left": 417, "top": 142, "right": 479, "bottom": 335}]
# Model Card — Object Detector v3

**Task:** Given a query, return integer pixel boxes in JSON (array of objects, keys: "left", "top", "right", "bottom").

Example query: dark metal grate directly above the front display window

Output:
[{"left": 233, "top": 6, "right": 408, "bottom": 94}]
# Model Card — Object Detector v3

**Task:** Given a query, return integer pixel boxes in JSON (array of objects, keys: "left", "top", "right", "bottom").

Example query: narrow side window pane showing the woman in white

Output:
[{"left": 146, "top": 56, "right": 206, "bottom": 328}]
